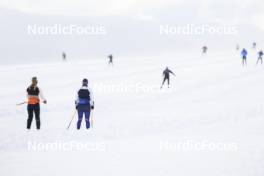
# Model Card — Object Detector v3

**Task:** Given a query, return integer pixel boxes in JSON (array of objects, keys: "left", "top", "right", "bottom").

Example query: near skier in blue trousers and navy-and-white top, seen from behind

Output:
[{"left": 75, "top": 79, "right": 94, "bottom": 130}]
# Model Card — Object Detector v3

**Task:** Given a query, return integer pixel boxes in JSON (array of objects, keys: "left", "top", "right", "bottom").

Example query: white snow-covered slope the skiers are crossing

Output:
[{"left": 0, "top": 52, "right": 264, "bottom": 176}]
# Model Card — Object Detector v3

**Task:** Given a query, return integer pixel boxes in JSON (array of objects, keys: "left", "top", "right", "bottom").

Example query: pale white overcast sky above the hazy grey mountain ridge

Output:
[{"left": 0, "top": 0, "right": 264, "bottom": 16}]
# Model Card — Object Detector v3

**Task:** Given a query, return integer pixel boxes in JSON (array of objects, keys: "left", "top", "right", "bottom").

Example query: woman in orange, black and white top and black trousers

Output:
[{"left": 27, "top": 77, "right": 47, "bottom": 130}]
